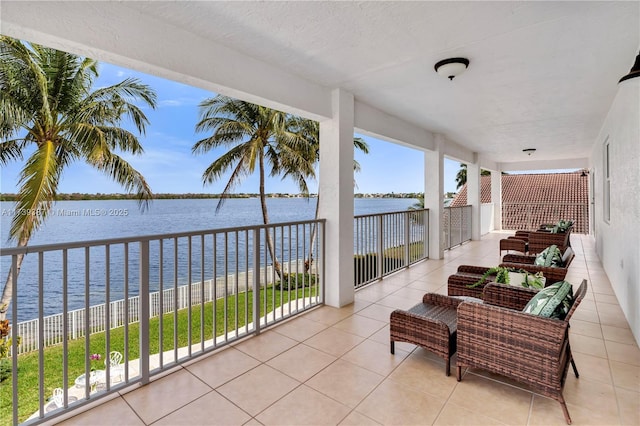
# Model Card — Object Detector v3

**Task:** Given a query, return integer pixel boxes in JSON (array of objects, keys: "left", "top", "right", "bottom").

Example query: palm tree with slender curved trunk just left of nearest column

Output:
[{"left": 192, "top": 95, "right": 315, "bottom": 276}]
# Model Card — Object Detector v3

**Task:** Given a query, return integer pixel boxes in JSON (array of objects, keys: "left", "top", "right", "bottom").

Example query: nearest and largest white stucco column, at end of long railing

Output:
[{"left": 318, "top": 89, "right": 354, "bottom": 307}]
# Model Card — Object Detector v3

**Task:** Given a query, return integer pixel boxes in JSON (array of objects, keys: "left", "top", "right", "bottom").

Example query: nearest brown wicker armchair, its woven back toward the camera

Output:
[{"left": 456, "top": 280, "right": 587, "bottom": 424}]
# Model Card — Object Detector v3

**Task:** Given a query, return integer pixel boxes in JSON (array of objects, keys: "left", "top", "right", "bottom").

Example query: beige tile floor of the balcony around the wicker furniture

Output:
[{"left": 51, "top": 233, "right": 640, "bottom": 425}]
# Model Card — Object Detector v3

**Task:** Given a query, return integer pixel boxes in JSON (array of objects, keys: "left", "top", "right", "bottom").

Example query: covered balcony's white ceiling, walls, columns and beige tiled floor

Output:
[{"left": 0, "top": 1, "right": 640, "bottom": 424}]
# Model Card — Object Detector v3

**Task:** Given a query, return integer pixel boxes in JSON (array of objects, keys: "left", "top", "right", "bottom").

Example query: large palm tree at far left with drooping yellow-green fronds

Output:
[{"left": 0, "top": 36, "right": 156, "bottom": 319}]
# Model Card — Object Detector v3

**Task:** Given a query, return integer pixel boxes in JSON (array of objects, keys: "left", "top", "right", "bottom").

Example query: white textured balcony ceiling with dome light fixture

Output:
[{"left": 0, "top": 1, "right": 640, "bottom": 168}]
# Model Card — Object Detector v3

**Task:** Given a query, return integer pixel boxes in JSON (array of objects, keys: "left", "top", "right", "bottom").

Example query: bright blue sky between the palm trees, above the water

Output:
[{"left": 0, "top": 63, "right": 460, "bottom": 193}]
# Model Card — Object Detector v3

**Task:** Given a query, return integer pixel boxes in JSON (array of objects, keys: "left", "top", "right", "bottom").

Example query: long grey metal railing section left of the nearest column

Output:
[{"left": 0, "top": 220, "right": 325, "bottom": 424}]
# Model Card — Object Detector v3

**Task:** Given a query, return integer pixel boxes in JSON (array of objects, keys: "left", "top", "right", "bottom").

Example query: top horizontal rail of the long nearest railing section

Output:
[{"left": 0, "top": 219, "right": 327, "bottom": 256}]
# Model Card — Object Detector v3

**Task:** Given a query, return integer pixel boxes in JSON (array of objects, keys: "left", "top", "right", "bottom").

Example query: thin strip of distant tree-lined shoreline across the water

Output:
[{"left": 0, "top": 192, "right": 422, "bottom": 201}]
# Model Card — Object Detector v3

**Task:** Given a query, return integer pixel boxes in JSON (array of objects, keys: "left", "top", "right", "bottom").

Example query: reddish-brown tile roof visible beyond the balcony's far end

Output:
[{"left": 451, "top": 171, "right": 589, "bottom": 234}]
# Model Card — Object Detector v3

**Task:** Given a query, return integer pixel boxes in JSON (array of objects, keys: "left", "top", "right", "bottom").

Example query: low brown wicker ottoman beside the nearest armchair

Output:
[{"left": 389, "top": 293, "right": 463, "bottom": 376}]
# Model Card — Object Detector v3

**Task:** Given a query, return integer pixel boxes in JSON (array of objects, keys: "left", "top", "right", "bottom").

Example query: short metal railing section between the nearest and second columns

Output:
[{"left": 354, "top": 209, "right": 429, "bottom": 288}]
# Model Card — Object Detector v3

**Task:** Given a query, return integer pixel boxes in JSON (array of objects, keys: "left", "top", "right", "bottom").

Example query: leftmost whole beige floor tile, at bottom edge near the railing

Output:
[{"left": 123, "top": 370, "right": 211, "bottom": 424}]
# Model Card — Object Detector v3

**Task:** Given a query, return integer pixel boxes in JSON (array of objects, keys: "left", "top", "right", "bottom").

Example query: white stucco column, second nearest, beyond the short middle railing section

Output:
[{"left": 424, "top": 134, "right": 444, "bottom": 259}]
